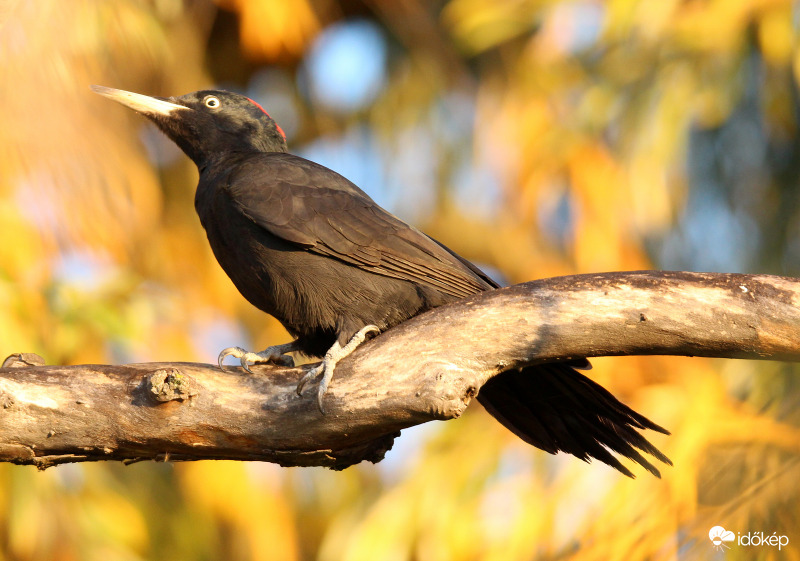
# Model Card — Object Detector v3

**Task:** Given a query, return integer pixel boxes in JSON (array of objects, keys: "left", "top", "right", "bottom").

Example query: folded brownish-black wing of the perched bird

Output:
[{"left": 226, "top": 153, "right": 496, "bottom": 297}]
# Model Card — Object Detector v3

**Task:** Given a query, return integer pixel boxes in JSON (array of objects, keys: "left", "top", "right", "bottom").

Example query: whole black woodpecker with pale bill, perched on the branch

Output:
[{"left": 94, "top": 86, "right": 669, "bottom": 476}]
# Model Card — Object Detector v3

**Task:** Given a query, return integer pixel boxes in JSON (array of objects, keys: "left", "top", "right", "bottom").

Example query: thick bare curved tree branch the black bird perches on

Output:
[{"left": 0, "top": 271, "right": 800, "bottom": 469}]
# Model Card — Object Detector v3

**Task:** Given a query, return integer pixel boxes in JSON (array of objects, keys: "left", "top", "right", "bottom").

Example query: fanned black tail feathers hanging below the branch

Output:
[{"left": 478, "top": 364, "right": 672, "bottom": 477}]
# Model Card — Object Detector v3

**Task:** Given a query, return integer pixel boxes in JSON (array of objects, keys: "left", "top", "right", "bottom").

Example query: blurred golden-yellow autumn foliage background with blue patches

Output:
[{"left": 0, "top": 0, "right": 800, "bottom": 561}]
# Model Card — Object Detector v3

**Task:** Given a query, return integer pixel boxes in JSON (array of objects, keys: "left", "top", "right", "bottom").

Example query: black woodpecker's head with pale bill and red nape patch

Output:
[{"left": 92, "top": 86, "right": 286, "bottom": 169}]
